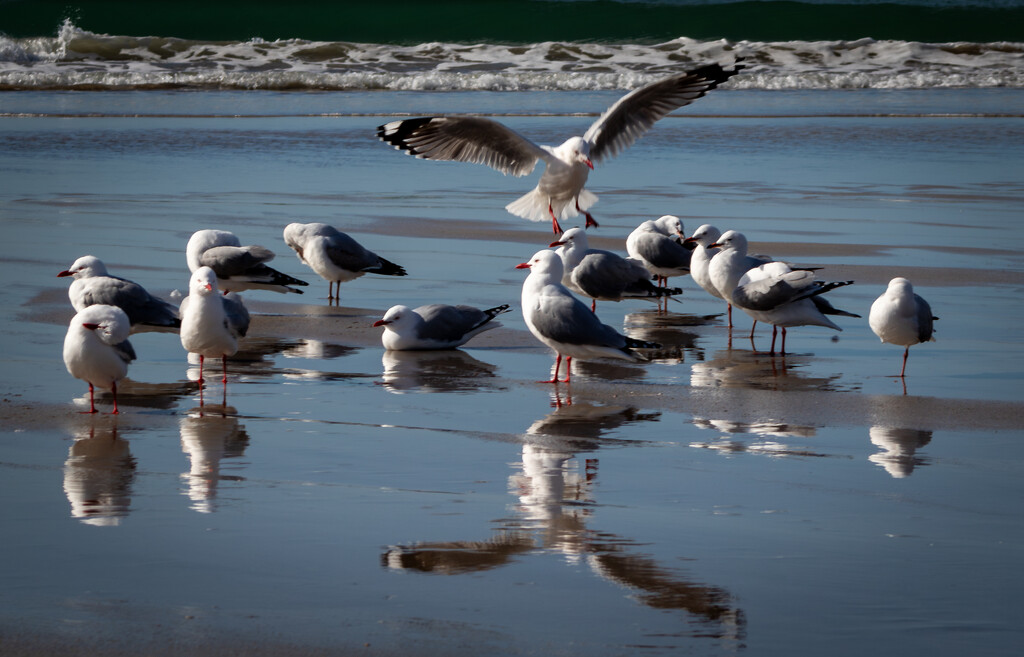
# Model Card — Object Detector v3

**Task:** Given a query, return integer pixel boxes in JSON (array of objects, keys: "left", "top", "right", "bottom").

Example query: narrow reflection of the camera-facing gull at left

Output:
[{"left": 179, "top": 404, "right": 249, "bottom": 514}]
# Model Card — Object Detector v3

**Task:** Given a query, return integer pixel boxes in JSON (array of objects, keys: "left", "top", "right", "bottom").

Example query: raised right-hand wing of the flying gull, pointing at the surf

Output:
[{"left": 583, "top": 63, "right": 743, "bottom": 162}]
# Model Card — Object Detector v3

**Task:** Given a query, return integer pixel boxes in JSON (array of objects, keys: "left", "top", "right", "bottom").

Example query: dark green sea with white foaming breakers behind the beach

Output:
[{"left": 0, "top": 0, "right": 1024, "bottom": 91}]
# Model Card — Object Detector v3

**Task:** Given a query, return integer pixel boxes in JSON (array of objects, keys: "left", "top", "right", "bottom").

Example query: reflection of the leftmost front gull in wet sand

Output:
[{"left": 63, "top": 419, "right": 135, "bottom": 526}]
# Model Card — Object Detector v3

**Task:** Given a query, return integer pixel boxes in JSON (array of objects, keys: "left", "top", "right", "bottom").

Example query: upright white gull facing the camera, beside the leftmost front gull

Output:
[{"left": 180, "top": 267, "right": 249, "bottom": 386}]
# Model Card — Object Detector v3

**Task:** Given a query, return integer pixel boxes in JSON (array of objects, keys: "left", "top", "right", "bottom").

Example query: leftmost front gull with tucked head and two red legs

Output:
[{"left": 63, "top": 304, "right": 135, "bottom": 414}]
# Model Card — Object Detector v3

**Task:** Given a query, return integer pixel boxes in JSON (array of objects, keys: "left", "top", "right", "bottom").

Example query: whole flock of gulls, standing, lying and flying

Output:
[{"left": 57, "top": 60, "right": 937, "bottom": 413}]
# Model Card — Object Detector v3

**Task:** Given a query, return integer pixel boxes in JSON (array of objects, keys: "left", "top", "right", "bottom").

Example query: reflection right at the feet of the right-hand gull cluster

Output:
[{"left": 690, "top": 349, "right": 841, "bottom": 392}]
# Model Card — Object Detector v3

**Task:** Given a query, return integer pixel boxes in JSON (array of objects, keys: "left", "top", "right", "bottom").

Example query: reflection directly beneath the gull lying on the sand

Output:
[{"left": 381, "top": 349, "right": 497, "bottom": 394}]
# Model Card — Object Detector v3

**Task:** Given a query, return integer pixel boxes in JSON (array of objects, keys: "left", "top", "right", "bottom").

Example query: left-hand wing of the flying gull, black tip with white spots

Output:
[{"left": 377, "top": 117, "right": 550, "bottom": 176}]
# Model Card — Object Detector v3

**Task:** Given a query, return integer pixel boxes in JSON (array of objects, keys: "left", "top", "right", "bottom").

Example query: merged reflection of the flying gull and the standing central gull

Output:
[{"left": 382, "top": 390, "right": 745, "bottom": 648}]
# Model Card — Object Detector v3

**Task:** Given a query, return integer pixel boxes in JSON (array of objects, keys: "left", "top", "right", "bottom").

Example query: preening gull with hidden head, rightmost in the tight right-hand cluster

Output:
[{"left": 733, "top": 259, "right": 860, "bottom": 356}]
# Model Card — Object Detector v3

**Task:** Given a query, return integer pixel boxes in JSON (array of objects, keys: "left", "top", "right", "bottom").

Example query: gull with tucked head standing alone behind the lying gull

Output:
[{"left": 285, "top": 223, "right": 407, "bottom": 299}]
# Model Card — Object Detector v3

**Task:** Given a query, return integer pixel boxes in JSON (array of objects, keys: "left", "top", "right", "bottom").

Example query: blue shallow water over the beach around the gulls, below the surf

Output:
[{"left": 0, "top": 91, "right": 1024, "bottom": 655}]
